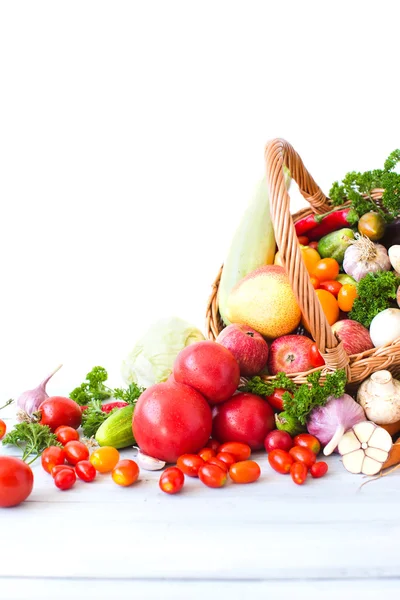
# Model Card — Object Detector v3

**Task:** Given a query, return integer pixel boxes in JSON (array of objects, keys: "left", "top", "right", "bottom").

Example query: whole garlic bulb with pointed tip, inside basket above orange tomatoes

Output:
[{"left": 343, "top": 234, "right": 392, "bottom": 281}]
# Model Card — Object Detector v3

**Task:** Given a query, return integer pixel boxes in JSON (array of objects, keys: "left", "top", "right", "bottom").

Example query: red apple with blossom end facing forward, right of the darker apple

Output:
[{"left": 268, "top": 335, "right": 313, "bottom": 375}]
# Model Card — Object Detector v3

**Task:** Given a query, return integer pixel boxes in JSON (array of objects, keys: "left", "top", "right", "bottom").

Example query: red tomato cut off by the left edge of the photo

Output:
[{"left": 0, "top": 456, "right": 33, "bottom": 508}]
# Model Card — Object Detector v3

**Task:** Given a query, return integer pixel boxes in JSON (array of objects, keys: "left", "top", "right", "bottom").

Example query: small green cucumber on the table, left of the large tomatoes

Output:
[{"left": 95, "top": 405, "right": 136, "bottom": 449}]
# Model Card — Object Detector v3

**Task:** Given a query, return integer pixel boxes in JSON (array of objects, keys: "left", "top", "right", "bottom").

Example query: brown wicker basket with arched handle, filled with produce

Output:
[{"left": 206, "top": 139, "right": 400, "bottom": 385}]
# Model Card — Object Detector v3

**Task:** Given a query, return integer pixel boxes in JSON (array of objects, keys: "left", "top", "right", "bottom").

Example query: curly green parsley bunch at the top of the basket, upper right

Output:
[{"left": 329, "top": 150, "right": 400, "bottom": 222}]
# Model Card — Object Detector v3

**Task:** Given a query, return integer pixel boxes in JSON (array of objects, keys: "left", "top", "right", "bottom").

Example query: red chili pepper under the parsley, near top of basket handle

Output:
[{"left": 295, "top": 208, "right": 359, "bottom": 240}]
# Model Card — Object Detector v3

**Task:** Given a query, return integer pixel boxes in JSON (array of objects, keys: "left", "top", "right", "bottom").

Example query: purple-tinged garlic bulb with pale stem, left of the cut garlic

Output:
[{"left": 307, "top": 394, "right": 366, "bottom": 456}]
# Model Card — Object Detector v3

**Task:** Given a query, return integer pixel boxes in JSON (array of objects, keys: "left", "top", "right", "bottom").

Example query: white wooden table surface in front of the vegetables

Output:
[{"left": 0, "top": 404, "right": 400, "bottom": 600}]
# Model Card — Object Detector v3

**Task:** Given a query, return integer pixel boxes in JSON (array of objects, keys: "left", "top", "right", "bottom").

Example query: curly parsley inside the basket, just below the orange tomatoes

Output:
[{"left": 349, "top": 271, "right": 400, "bottom": 328}]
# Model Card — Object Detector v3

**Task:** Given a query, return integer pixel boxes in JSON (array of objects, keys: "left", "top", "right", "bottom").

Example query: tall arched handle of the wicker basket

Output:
[{"left": 265, "top": 139, "right": 350, "bottom": 375}]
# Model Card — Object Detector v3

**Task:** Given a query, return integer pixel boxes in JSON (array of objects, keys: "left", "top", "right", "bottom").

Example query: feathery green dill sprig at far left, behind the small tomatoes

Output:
[{"left": 3, "top": 422, "right": 61, "bottom": 465}]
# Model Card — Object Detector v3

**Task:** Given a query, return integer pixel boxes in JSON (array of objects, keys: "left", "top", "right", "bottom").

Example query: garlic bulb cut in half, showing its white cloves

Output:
[{"left": 338, "top": 421, "right": 393, "bottom": 475}]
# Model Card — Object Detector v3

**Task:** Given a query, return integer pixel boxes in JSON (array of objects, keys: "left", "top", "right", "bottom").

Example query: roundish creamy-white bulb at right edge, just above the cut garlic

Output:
[{"left": 357, "top": 371, "right": 400, "bottom": 425}]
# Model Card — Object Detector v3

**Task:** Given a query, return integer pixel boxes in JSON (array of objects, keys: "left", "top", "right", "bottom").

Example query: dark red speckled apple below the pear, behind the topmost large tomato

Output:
[{"left": 216, "top": 323, "right": 268, "bottom": 377}]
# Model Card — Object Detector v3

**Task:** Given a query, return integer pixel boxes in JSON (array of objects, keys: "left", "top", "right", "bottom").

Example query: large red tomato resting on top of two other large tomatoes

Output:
[{"left": 174, "top": 341, "right": 240, "bottom": 404}]
